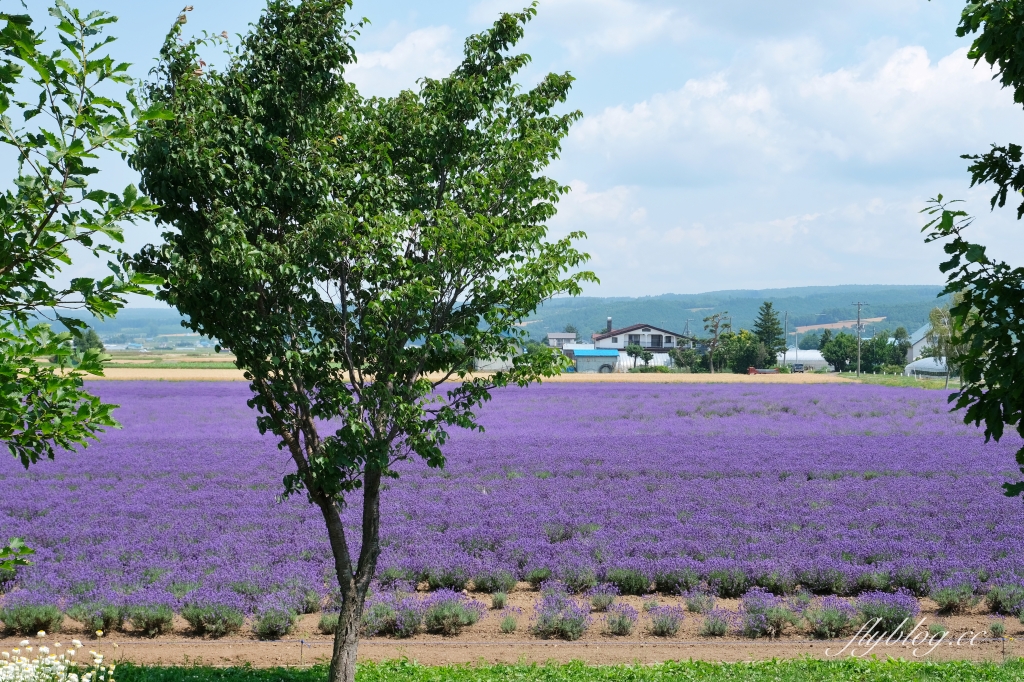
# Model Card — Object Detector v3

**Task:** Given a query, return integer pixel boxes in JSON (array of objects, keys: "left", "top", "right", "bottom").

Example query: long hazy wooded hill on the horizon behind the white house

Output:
[{"left": 526, "top": 285, "right": 943, "bottom": 340}]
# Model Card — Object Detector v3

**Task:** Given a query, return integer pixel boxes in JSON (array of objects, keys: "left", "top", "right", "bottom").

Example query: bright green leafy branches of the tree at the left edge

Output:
[{"left": 0, "top": 0, "right": 160, "bottom": 466}]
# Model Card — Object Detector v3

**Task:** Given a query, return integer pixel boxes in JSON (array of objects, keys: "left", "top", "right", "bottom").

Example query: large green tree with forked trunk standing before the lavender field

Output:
[{"left": 133, "top": 0, "right": 596, "bottom": 681}]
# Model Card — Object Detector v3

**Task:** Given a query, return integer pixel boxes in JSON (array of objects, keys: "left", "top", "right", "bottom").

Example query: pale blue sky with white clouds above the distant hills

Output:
[{"left": 28, "top": 0, "right": 1024, "bottom": 296}]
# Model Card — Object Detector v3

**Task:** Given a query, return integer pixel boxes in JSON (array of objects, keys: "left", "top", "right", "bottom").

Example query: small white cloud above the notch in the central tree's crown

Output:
[{"left": 345, "top": 26, "right": 461, "bottom": 96}]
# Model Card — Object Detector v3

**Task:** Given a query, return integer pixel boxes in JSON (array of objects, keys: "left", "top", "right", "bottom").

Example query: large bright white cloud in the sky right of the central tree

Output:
[{"left": 570, "top": 38, "right": 1020, "bottom": 175}]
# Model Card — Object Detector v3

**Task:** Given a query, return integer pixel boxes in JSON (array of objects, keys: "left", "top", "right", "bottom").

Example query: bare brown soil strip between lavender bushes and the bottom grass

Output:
[{"left": 8, "top": 585, "right": 1011, "bottom": 667}]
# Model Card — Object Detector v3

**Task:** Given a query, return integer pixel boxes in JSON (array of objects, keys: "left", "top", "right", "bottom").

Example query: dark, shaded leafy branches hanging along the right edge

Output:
[{"left": 922, "top": 0, "right": 1024, "bottom": 496}]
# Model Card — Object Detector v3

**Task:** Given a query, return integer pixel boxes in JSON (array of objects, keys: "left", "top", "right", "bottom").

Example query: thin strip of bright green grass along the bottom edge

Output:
[{"left": 117, "top": 658, "right": 1024, "bottom": 682}]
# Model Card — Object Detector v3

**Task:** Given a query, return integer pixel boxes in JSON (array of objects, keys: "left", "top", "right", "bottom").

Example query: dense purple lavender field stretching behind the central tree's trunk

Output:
[{"left": 0, "top": 382, "right": 1024, "bottom": 611}]
